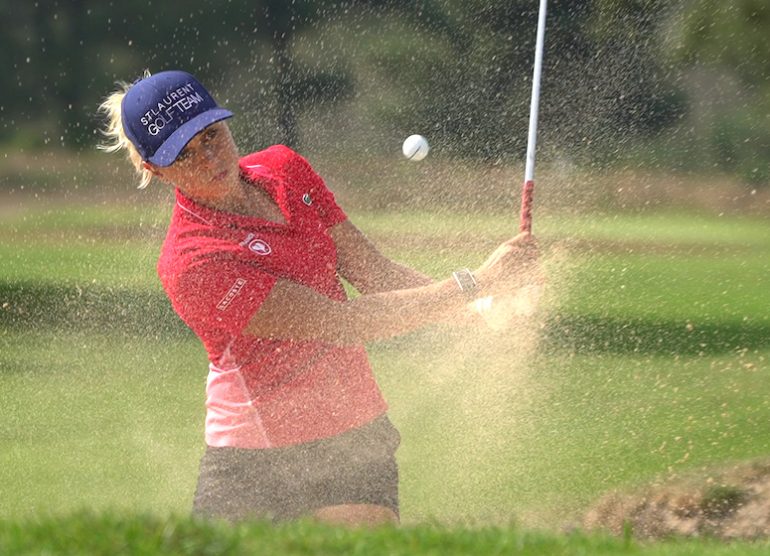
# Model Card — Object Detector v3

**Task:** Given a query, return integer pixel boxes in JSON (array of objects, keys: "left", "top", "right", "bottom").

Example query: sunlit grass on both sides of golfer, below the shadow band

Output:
[{"left": 0, "top": 331, "right": 770, "bottom": 525}]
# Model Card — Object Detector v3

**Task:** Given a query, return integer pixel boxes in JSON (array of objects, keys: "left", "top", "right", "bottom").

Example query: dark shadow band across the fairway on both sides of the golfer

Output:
[{"left": 0, "top": 283, "right": 770, "bottom": 355}]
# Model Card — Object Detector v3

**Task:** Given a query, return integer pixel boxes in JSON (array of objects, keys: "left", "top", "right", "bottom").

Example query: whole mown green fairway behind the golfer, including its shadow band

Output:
[{"left": 0, "top": 198, "right": 770, "bottom": 554}]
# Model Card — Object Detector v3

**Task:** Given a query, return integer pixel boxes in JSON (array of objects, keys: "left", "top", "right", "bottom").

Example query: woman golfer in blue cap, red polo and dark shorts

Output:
[{"left": 101, "top": 71, "right": 536, "bottom": 524}]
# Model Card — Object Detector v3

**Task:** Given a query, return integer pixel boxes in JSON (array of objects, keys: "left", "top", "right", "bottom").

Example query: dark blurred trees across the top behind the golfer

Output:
[{"left": 0, "top": 0, "right": 770, "bottom": 182}]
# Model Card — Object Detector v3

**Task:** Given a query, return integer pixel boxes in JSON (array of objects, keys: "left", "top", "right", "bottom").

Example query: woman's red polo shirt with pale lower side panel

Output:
[{"left": 158, "top": 146, "right": 387, "bottom": 448}]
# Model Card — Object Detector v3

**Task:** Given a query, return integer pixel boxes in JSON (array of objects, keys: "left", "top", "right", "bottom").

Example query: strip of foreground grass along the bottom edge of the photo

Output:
[{"left": 0, "top": 513, "right": 768, "bottom": 556}]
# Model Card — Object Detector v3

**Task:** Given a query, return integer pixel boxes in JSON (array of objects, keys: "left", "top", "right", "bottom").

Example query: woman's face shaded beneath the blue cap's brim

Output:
[{"left": 146, "top": 122, "right": 240, "bottom": 196}]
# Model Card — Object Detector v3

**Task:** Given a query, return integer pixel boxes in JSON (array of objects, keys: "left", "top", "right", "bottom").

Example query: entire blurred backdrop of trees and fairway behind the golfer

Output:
[{"left": 0, "top": 0, "right": 770, "bottom": 527}]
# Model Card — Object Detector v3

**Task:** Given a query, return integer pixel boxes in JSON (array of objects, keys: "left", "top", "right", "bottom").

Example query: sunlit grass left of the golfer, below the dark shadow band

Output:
[{"left": 0, "top": 330, "right": 207, "bottom": 517}]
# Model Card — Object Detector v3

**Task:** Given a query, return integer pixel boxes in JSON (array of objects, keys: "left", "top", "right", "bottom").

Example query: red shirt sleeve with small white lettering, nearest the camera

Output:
[{"left": 175, "top": 255, "right": 278, "bottom": 337}]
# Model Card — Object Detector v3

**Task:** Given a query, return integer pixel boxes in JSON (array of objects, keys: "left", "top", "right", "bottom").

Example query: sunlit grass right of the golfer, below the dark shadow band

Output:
[{"left": 373, "top": 338, "right": 770, "bottom": 526}]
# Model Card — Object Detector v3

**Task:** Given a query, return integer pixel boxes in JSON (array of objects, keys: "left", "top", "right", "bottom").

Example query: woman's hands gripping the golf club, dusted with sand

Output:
[{"left": 473, "top": 232, "right": 543, "bottom": 295}]
